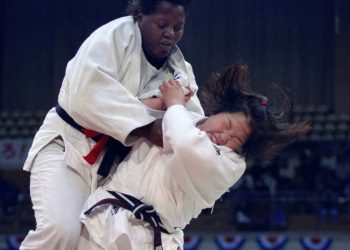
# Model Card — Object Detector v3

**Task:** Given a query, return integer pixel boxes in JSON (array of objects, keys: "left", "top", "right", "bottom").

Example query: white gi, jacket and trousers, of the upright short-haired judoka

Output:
[{"left": 20, "top": 16, "right": 203, "bottom": 250}]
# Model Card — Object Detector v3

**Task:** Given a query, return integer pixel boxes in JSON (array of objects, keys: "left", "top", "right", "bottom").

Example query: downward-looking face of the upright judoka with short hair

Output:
[{"left": 137, "top": 1, "right": 186, "bottom": 64}]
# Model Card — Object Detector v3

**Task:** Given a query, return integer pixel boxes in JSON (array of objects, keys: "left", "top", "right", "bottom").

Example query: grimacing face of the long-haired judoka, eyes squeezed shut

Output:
[{"left": 198, "top": 112, "right": 252, "bottom": 150}]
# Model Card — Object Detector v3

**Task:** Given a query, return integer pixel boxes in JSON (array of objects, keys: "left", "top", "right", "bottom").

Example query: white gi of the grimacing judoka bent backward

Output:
[{"left": 78, "top": 105, "right": 246, "bottom": 250}]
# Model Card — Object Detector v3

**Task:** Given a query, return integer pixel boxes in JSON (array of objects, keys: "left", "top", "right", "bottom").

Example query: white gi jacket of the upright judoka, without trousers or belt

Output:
[{"left": 24, "top": 16, "right": 203, "bottom": 189}]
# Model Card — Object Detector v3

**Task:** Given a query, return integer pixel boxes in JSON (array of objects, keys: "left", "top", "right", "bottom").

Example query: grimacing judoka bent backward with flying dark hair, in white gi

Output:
[{"left": 78, "top": 64, "right": 309, "bottom": 250}]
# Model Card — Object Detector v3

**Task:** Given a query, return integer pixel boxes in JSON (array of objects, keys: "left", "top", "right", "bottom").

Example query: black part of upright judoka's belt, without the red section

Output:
[{"left": 56, "top": 105, "right": 131, "bottom": 177}]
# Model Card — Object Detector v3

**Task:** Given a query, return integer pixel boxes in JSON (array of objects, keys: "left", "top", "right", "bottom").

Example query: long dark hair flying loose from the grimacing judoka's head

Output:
[{"left": 199, "top": 63, "right": 310, "bottom": 159}]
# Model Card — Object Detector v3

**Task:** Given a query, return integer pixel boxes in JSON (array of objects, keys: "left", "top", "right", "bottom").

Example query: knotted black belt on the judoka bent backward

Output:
[{"left": 84, "top": 191, "right": 169, "bottom": 250}]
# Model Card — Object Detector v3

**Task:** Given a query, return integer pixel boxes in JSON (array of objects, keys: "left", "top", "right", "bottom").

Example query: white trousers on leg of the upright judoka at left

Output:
[{"left": 20, "top": 139, "right": 90, "bottom": 250}]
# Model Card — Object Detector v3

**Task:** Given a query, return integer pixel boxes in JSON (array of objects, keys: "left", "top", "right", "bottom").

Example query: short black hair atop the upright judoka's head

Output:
[{"left": 126, "top": 0, "right": 193, "bottom": 17}]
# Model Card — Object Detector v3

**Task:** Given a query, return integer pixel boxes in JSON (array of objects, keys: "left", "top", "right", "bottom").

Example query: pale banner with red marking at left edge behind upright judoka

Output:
[{"left": 0, "top": 138, "right": 33, "bottom": 169}]
